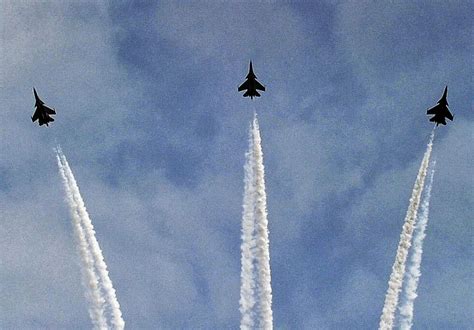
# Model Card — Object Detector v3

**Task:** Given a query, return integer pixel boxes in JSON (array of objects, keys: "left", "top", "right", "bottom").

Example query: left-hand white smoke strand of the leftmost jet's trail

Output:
[{"left": 56, "top": 155, "right": 107, "bottom": 329}]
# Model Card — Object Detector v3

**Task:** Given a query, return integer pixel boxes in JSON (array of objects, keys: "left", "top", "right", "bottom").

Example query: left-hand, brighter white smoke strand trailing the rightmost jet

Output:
[{"left": 379, "top": 130, "right": 434, "bottom": 330}]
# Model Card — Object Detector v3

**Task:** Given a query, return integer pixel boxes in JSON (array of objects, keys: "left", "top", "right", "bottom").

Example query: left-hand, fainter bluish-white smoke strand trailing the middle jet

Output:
[{"left": 240, "top": 122, "right": 256, "bottom": 330}]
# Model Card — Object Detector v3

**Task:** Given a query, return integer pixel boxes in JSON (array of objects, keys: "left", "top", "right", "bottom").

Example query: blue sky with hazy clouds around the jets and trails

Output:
[{"left": 0, "top": 1, "right": 474, "bottom": 329}]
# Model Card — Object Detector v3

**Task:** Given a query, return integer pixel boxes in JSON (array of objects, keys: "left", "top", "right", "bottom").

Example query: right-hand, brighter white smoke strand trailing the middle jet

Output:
[{"left": 252, "top": 114, "right": 273, "bottom": 329}]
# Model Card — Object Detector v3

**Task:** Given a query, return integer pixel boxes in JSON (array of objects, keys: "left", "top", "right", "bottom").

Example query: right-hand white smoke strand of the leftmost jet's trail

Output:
[{"left": 58, "top": 148, "right": 125, "bottom": 329}]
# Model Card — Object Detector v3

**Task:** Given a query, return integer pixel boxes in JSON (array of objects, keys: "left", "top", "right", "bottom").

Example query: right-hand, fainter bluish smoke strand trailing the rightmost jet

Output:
[{"left": 399, "top": 162, "right": 436, "bottom": 330}]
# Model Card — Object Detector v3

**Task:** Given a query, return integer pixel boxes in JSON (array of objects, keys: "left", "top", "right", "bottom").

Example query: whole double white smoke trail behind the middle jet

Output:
[{"left": 240, "top": 114, "right": 273, "bottom": 329}]
